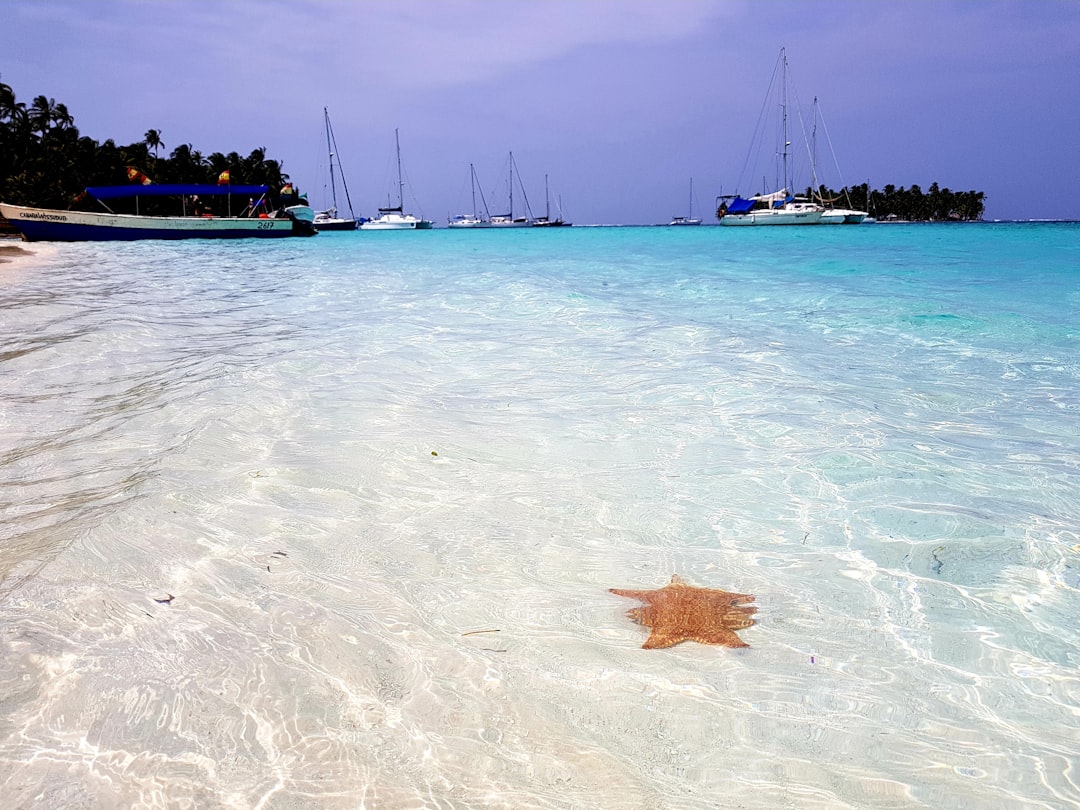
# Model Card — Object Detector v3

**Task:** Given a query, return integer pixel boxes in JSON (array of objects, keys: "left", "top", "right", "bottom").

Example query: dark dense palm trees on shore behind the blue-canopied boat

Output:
[{"left": 0, "top": 83, "right": 288, "bottom": 213}]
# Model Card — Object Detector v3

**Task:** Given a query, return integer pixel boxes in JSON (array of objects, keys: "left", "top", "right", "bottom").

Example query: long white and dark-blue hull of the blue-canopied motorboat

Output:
[{"left": 0, "top": 204, "right": 314, "bottom": 242}]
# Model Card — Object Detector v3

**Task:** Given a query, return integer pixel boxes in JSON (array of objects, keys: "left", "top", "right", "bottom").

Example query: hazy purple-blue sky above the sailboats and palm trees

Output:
[{"left": 0, "top": 0, "right": 1080, "bottom": 224}]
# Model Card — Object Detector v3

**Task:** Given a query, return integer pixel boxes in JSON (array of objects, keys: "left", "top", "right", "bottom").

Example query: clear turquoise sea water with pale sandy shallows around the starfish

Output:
[{"left": 0, "top": 224, "right": 1080, "bottom": 810}]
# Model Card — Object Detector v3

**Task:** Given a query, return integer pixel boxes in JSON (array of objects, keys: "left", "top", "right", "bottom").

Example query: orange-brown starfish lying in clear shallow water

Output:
[{"left": 610, "top": 576, "right": 757, "bottom": 650}]
